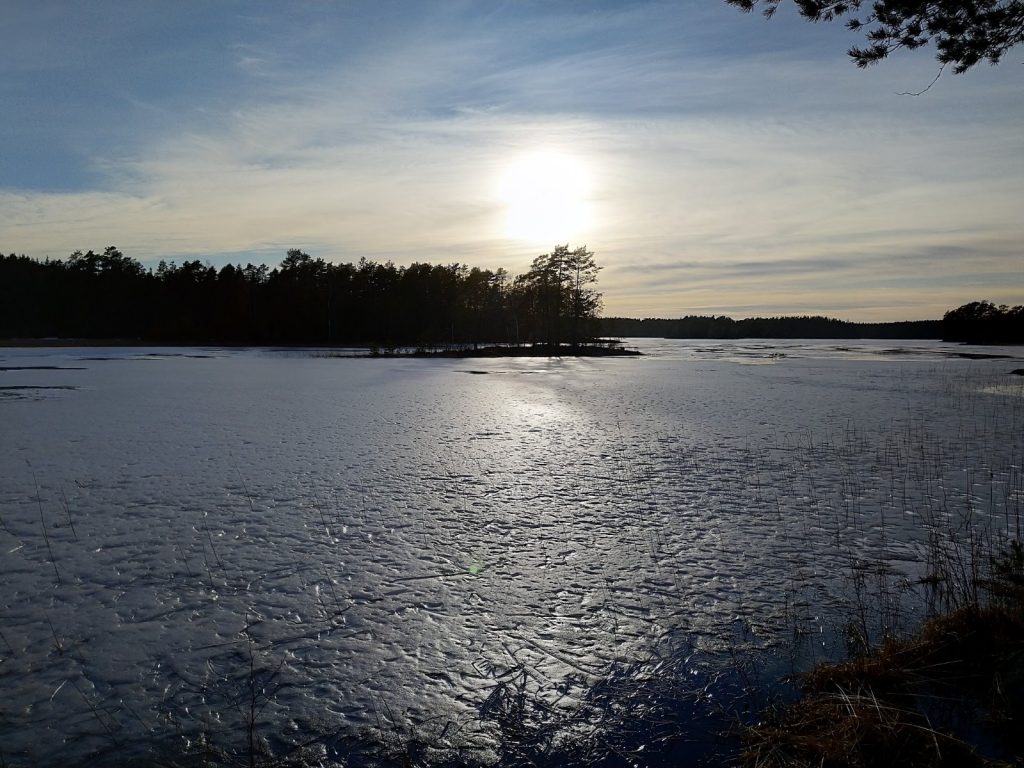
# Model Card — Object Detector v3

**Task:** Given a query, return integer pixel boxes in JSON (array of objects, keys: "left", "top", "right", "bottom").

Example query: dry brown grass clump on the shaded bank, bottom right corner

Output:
[{"left": 742, "top": 540, "right": 1024, "bottom": 768}]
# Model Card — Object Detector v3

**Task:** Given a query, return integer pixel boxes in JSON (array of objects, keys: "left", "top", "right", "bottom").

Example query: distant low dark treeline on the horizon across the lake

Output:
[{"left": 599, "top": 315, "right": 944, "bottom": 339}]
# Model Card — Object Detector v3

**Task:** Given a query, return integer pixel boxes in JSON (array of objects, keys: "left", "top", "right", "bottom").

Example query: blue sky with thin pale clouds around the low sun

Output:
[{"left": 0, "top": 0, "right": 1024, "bottom": 321}]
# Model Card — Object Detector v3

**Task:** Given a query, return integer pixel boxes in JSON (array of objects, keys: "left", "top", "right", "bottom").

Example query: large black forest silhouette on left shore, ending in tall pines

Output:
[{"left": 0, "top": 246, "right": 600, "bottom": 346}]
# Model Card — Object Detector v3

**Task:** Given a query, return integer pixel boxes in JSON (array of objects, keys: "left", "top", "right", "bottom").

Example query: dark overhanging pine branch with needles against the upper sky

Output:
[{"left": 726, "top": 0, "right": 1024, "bottom": 74}]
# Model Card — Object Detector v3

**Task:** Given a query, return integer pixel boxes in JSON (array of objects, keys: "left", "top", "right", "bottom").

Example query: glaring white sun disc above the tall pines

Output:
[{"left": 501, "top": 152, "right": 590, "bottom": 245}]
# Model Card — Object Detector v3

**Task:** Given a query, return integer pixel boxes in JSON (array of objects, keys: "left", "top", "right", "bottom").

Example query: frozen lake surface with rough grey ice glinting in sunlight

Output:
[{"left": 0, "top": 339, "right": 1024, "bottom": 766}]
